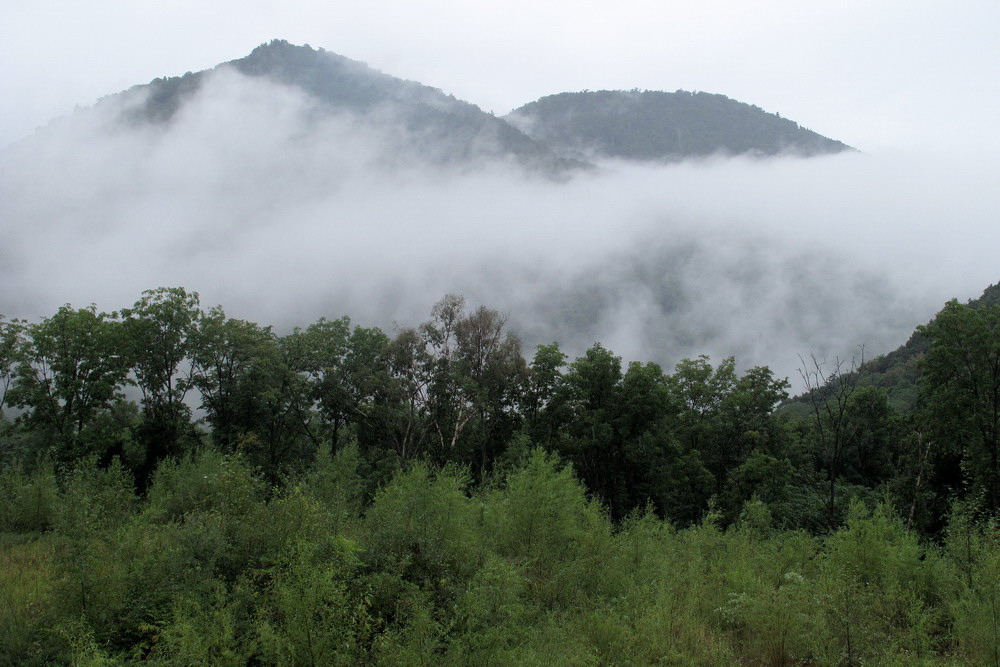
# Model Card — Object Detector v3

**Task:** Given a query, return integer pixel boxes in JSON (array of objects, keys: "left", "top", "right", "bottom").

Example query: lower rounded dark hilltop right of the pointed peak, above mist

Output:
[{"left": 506, "top": 90, "right": 850, "bottom": 160}]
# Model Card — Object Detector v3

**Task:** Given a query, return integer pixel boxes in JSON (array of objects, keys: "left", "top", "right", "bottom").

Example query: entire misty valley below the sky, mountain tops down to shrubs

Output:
[{"left": 0, "top": 40, "right": 1000, "bottom": 665}]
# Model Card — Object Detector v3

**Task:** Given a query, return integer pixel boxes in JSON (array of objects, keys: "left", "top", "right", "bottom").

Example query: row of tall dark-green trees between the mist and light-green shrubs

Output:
[{"left": 0, "top": 288, "right": 1000, "bottom": 534}]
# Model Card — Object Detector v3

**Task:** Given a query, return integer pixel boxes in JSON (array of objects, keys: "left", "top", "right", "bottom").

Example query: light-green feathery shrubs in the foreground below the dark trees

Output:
[{"left": 0, "top": 452, "right": 1000, "bottom": 665}]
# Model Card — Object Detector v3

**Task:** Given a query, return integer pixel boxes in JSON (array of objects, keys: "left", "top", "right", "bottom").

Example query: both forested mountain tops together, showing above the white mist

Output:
[{"left": 52, "top": 40, "right": 849, "bottom": 173}]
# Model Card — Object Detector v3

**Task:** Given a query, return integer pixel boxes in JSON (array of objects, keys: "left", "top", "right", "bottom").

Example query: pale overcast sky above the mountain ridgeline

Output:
[{"left": 0, "top": 0, "right": 1000, "bottom": 152}]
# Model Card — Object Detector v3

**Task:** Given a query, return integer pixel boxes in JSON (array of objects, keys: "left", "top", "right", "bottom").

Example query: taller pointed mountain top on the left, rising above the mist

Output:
[{"left": 113, "top": 40, "right": 585, "bottom": 170}]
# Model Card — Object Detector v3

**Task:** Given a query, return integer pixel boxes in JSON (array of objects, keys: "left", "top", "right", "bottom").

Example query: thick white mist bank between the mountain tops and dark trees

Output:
[{"left": 0, "top": 71, "right": 1000, "bottom": 386}]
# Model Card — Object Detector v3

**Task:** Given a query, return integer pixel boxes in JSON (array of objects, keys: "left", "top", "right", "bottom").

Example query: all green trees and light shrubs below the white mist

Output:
[{"left": 0, "top": 287, "right": 1000, "bottom": 665}]
